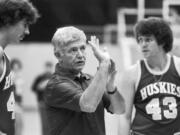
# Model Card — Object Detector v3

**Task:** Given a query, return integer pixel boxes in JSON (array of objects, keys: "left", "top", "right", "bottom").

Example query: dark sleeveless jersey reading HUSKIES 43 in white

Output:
[{"left": 131, "top": 57, "right": 180, "bottom": 135}]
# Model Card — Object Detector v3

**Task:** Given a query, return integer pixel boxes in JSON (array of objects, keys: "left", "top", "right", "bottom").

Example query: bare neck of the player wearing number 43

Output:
[{"left": 147, "top": 53, "right": 168, "bottom": 71}]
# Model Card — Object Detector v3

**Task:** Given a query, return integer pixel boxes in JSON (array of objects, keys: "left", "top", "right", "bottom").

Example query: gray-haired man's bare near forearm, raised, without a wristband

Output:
[{"left": 80, "top": 61, "right": 109, "bottom": 112}]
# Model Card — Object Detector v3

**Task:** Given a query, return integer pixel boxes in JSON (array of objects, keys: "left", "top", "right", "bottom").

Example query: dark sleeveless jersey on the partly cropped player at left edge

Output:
[{"left": 0, "top": 55, "right": 15, "bottom": 135}]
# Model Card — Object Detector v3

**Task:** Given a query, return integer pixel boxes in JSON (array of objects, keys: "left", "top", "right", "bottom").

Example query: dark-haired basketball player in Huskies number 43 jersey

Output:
[{"left": 120, "top": 17, "right": 180, "bottom": 135}]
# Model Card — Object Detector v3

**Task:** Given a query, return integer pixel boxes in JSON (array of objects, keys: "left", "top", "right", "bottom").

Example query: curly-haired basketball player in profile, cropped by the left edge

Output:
[{"left": 0, "top": 0, "right": 39, "bottom": 135}]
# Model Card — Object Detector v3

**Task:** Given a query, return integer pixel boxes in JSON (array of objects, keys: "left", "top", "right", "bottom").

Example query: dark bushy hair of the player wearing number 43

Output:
[{"left": 134, "top": 17, "right": 173, "bottom": 52}]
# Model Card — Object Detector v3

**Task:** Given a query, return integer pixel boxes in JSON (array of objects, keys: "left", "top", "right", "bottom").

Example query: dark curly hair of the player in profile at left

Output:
[{"left": 0, "top": 0, "right": 40, "bottom": 28}]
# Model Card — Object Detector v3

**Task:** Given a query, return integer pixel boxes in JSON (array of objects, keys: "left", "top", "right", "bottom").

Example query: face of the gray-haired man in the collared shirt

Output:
[{"left": 60, "top": 41, "right": 86, "bottom": 72}]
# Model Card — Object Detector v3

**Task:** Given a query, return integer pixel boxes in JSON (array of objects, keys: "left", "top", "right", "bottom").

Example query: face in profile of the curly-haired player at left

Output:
[{"left": 8, "top": 20, "right": 30, "bottom": 43}]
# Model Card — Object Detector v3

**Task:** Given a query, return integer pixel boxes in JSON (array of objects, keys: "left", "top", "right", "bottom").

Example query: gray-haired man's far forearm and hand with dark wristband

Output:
[{"left": 106, "top": 60, "right": 125, "bottom": 114}]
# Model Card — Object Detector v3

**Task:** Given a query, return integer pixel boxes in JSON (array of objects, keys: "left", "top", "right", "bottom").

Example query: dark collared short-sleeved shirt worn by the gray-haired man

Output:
[{"left": 44, "top": 64, "right": 110, "bottom": 135}]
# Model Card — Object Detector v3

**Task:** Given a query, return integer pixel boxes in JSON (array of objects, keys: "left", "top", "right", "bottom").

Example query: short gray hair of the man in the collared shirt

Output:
[{"left": 52, "top": 26, "right": 86, "bottom": 53}]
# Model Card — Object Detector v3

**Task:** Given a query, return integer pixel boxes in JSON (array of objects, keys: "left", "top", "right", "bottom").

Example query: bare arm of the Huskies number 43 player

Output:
[{"left": 119, "top": 64, "right": 137, "bottom": 135}]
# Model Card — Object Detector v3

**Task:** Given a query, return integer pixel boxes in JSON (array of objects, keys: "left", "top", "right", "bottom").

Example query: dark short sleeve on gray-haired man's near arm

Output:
[{"left": 44, "top": 79, "right": 83, "bottom": 112}]
